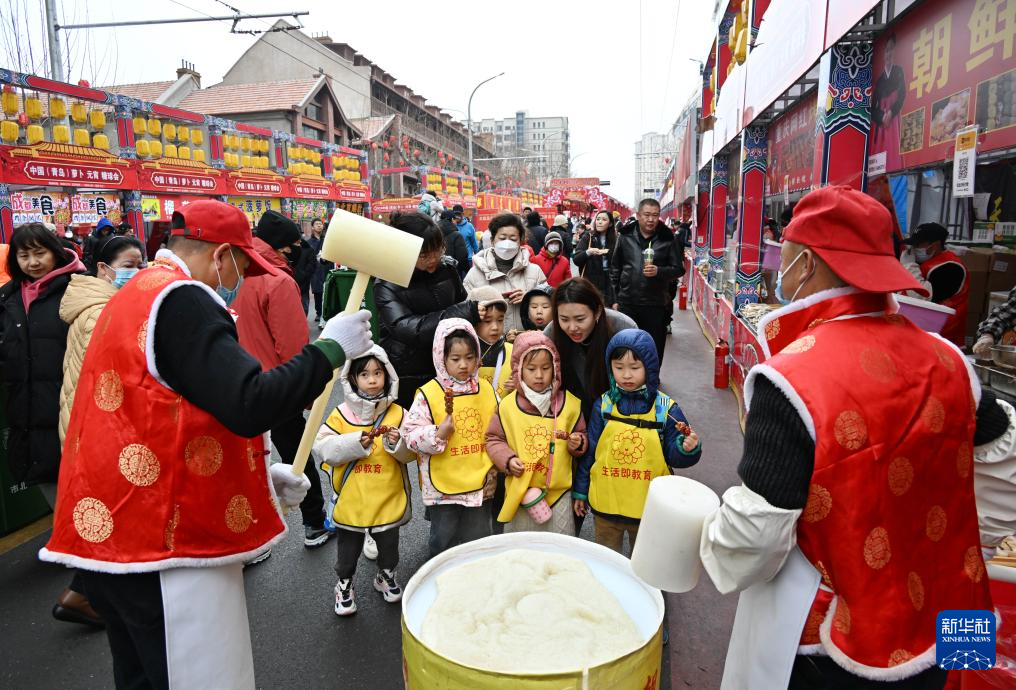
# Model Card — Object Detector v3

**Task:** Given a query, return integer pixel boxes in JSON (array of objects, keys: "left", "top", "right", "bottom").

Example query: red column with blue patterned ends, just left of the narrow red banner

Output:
[{"left": 734, "top": 127, "right": 769, "bottom": 308}]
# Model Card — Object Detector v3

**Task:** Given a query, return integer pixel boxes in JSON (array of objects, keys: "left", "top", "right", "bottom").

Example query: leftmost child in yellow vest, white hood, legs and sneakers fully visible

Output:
[{"left": 313, "top": 344, "right": 416, "bottom": 616}]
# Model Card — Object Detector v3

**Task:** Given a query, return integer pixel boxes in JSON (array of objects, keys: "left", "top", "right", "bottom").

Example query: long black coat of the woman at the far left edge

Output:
[{"left": 0, "top": 274, "right": 70, "bottom": 484}]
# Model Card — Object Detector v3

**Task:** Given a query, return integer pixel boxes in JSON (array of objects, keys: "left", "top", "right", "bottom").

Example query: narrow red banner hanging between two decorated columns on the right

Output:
[{"left": 766, "top": 93, "right": 818, "bottom": 194}]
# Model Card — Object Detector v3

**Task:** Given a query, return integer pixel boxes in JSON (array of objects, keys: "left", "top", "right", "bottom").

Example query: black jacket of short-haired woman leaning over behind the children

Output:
[{"left": 374, "top": 257, "right": 480, "bottom": 380}]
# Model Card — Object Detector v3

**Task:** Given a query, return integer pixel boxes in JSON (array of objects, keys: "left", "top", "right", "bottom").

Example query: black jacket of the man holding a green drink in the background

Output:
[{"left": 611, "top": 219, "right": 685, "bottom": 307}]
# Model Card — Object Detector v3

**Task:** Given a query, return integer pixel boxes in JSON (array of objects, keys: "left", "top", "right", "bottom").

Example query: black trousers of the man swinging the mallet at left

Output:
[{"left": 78, "top": 570, "right": 170, "bottom": 690}]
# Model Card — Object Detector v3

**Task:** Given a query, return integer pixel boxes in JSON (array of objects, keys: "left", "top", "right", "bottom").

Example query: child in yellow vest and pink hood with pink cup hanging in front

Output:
[{"left": 487, "top": 331, "right": 587, "bottom": 535}]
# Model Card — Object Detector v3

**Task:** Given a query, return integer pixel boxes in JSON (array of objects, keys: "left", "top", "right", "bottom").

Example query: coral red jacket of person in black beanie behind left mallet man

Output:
[{"left": 233, "top": 238, "right": 309, "bottom": 371}]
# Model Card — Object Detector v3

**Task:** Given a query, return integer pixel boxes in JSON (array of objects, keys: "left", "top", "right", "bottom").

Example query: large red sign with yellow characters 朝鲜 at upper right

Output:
[{"left": 869, "top": 0, "right": 1016, "bottom": 173}]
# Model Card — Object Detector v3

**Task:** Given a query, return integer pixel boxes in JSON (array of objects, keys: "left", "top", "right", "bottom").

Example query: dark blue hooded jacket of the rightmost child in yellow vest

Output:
[{"left": 572, "top": 328, "right": 702, "bottom": 512}]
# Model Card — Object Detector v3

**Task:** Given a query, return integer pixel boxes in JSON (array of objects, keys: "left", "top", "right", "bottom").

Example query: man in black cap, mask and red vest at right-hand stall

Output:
[{"left": 900, "top": 223, "right": 970, "bottom": 346}]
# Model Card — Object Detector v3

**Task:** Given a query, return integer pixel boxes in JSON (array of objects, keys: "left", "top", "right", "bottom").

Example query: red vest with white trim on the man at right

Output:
[{"left": 758, "top": 293, "right": 992, "bottom": 680}]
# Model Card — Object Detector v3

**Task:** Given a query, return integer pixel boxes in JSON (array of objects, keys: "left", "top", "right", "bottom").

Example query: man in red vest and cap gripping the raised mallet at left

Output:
[{"left": 40, "top": 201, "right": 370, "bottom": 689}]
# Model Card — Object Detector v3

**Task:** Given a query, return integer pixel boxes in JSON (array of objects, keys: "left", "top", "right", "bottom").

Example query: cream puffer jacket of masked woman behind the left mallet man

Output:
[{"left": 59, "top": 275, "right": 117, "bottom": 446}]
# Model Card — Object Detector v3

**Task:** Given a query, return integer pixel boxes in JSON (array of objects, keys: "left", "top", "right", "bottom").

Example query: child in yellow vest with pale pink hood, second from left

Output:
[{"left": 402, "top": 318, "right": 498, "bottom": 556}]
